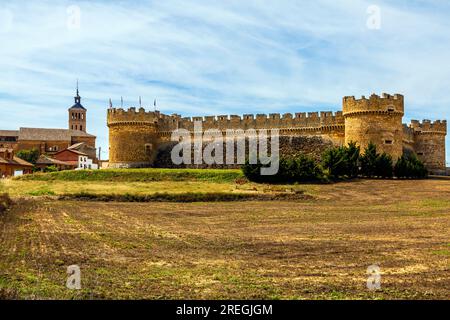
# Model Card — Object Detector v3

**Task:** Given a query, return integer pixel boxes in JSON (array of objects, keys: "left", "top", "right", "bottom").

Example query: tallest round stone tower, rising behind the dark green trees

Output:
[{"left": 343, "top": 93, "right": 404, "bottom": 162}]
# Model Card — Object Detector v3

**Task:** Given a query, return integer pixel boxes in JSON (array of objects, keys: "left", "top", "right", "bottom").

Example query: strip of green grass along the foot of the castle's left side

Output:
[{"left": 14, "top": 168, "right": 244, "bottom": 182}]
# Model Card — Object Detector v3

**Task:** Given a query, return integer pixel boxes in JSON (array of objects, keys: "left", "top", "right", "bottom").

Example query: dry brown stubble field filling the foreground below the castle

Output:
[{"left": 0, "top": 180, "right": 450, "bottom": 299}]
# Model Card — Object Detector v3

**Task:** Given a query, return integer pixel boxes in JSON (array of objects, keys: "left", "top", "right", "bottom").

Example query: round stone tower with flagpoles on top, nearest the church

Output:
[{"left": 108, "top": 108, "right": 159, "bottom": 168}]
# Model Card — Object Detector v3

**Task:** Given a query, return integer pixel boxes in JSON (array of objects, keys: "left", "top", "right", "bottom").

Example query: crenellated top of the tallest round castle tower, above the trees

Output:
[{"left": 342, "top": 93, "right": 405, "bottom": 116}]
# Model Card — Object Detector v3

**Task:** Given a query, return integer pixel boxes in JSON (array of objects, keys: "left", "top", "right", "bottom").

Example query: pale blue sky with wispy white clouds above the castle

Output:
[{"left": 0, "top": 0, "right": 450, "bottom": 161}]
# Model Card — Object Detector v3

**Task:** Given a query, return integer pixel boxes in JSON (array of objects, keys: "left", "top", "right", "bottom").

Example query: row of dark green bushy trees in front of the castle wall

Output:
[{"left": 242, "top": 142, "right": 428, "bottom": 183}]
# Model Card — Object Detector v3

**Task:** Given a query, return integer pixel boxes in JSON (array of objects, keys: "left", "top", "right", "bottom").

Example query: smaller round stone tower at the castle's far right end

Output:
[{"left": 410, "top": 120, "right": 447, "bottom": 174}]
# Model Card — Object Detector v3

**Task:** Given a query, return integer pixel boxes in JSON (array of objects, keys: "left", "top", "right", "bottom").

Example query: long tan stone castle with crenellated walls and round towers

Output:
[{"left": 107, "top": 93, "right": 447, "bottom": 174}]
